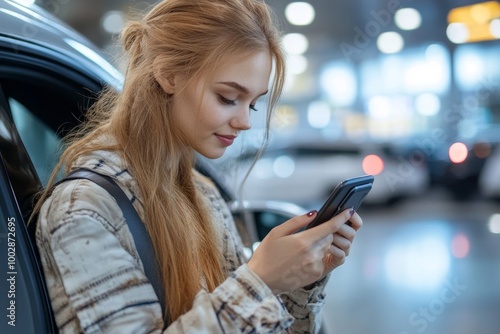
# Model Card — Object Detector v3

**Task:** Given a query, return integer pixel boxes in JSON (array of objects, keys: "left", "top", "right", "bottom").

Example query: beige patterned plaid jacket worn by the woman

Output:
[{"left": 37, "top": 147, "right": 327, "bottom": 334}]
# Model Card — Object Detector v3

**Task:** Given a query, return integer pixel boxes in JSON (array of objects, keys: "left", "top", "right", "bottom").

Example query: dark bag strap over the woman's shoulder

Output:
[{"left": 56, "top": 168, "right": 166, "bottom": 311}]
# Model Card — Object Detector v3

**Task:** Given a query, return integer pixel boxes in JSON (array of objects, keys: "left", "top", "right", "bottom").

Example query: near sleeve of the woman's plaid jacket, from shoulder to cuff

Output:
[{"left": 37, "top": 180, "right": 293, "bottom": 333}]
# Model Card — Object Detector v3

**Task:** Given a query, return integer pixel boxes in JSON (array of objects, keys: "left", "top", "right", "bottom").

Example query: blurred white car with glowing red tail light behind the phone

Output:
[{"left": 231, "top": 141, "right": 429, "bottom": 207}]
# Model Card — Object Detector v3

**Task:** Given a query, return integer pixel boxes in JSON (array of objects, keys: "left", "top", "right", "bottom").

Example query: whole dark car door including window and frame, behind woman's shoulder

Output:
[{"left": 0, "top": 24, "right": 113, "bottom": 334}]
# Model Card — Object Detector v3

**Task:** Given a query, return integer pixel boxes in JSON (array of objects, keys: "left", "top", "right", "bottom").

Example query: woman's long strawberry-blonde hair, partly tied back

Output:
[{"left": 36, "top": 0, "right": 285, "bottom": 321}]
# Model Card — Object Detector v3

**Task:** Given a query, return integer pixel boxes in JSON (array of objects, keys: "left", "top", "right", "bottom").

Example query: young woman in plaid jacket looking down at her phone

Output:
[{"left": 37, "top": 0, "right": 362, "bottom": 334}]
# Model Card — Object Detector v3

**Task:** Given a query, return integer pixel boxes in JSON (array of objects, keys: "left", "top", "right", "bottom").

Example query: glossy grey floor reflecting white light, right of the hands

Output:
[{"left": 324, "top": 188, "right": 500, "bottom": 334}]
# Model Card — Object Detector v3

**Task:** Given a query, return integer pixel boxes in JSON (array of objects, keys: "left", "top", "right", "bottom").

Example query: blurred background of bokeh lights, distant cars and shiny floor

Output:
[{"left": 29, "top": 0, "right": 500, "bottom": 334}]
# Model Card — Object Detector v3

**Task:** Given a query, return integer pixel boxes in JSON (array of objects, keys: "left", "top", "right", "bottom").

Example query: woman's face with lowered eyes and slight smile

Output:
[{"left": 171, "top": 52, "right": 272, "bottom": 159}]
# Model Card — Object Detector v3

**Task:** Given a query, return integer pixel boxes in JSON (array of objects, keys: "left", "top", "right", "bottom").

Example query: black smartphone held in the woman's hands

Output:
[{"left": 306, "top": 175, "right": 374, "bottom": 229}]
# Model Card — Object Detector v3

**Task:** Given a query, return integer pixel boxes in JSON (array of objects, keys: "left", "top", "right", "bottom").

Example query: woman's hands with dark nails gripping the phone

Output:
[{"left": 248, "top": 210, "right": 363, "bottom": 294}]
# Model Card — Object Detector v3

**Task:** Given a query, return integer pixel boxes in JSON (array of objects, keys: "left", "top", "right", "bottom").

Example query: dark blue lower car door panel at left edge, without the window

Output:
[{"left": 0, "top": 82, "right": 56, "bottom": 334}]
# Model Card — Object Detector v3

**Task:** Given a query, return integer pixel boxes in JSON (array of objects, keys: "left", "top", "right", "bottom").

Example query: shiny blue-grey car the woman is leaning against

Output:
[{"left": 0, "top": 0, "right": 305, "bottom": 334}]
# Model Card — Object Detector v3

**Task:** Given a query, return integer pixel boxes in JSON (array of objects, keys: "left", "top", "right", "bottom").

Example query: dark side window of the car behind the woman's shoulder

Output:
[{"left": 0, "top": 59, "right": 102, "bottom": 186}]
